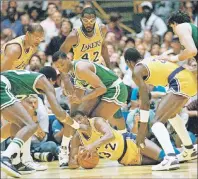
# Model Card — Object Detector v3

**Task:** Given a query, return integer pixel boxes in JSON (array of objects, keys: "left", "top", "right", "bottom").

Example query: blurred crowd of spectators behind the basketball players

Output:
[{"left": 1, "top": 0, "right": 198, "bottom": 162}]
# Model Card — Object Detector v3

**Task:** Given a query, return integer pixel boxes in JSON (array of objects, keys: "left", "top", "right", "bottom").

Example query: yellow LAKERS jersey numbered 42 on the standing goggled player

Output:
[{"left": 73, "top": 24, "right": 104, "bottom": 63}]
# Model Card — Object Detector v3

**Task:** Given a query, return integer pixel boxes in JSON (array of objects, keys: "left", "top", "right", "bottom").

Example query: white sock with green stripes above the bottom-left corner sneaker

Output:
[{"left": 2, "top": 138, "right": 24, "bottom": 158}]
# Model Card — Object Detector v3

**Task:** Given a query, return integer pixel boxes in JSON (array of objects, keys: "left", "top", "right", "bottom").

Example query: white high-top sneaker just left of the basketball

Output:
[{"left": 58, "top": 146, "right": 69, "bottom": 168}]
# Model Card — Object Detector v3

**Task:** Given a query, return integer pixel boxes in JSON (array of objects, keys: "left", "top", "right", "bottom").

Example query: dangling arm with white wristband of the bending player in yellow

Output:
[{"left": 133, "top": 65, "right": 150, "bottom": 148}]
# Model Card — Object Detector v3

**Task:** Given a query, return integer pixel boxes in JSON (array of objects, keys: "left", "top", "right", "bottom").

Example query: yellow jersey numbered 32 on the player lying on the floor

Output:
[{"left": 78, "top": 118, "right": 124, "bottom": 160}]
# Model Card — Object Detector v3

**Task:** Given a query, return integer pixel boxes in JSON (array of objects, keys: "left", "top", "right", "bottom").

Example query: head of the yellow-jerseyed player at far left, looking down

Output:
[{"left": 26, "top": 24, "right": 44, "bottom": 47}]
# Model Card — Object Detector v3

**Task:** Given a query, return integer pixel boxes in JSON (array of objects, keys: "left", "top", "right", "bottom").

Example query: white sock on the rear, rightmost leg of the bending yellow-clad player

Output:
[{"left": 169, "top": 114, "right": 192, "bottom": 146}]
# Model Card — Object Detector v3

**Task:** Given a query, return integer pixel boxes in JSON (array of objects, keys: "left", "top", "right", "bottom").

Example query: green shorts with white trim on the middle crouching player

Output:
[{"left": 101, "top": 82, "right": 128, "bottom": 106}]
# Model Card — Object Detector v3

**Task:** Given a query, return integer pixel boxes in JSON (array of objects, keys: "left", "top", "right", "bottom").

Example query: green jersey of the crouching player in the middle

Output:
[{"left": 73, "top": 60, "right": 118, "bottom": 89}]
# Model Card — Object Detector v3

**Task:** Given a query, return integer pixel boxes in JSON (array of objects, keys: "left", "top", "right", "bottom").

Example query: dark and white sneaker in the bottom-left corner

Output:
[{"left": 1, "top": 156, "right": 21, "bottom": 178}]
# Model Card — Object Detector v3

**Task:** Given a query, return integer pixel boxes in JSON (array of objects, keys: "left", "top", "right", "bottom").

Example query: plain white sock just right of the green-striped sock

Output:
[{"left": 21, "top": 137, "right": 32, "bottom": 163}]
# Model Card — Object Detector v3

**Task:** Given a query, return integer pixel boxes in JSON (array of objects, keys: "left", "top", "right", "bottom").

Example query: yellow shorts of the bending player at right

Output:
[{"left": 168, "top": 67, "right": 197, "bottom": 98}]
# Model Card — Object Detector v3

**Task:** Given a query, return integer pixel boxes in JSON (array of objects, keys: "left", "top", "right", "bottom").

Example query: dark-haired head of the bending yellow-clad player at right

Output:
[{"left": 124, "top": 48, "right": 142, "bottom": 68}]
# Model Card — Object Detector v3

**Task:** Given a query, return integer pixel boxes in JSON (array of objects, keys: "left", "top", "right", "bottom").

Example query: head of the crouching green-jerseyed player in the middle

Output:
[{"left": 52, "top": 51, "right": 71, "bottom": 73}]
